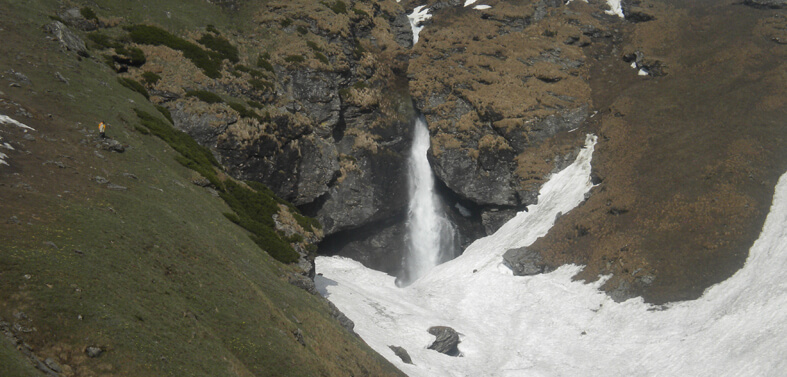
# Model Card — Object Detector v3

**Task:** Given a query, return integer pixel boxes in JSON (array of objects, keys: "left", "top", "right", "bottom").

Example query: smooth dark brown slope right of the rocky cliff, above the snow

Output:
[{"left": 533, "top": 0, "right": 787, "bottom": 303}]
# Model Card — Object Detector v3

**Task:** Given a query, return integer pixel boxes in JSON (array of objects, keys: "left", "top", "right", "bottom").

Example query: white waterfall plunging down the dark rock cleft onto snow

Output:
[{"left": 397, "top": 117, "right": 457, "bottom": 285}]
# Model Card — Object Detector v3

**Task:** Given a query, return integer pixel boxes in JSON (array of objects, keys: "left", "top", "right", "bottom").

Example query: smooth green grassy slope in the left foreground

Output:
[{"left": 0, "top": 1, "right": 398, "bottom": 376}]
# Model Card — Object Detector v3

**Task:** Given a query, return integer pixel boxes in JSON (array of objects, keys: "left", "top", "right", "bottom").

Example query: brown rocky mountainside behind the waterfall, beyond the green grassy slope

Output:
[{"left": 120, "top": 0, "right": 787, "bottom": 301}]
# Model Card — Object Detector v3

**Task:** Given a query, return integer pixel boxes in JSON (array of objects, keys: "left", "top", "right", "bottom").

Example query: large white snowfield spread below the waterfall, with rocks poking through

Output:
[{"left": 316, "top": 136, "right": 787, "bottom": 377}]
